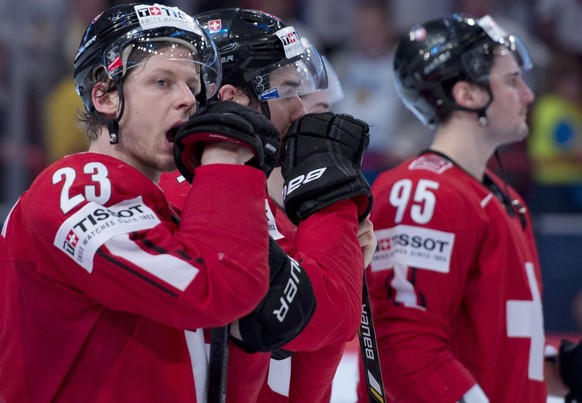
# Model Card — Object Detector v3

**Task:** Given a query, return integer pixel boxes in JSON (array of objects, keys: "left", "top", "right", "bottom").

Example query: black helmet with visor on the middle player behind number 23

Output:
[{"left": 194, "top": 8, "right": 327, "bottom": 103}]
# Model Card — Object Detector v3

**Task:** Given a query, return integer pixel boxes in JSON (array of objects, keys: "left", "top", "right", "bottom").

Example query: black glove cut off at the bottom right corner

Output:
[{"left": 558, "top": 339, "right": 582, "bottom": 403}]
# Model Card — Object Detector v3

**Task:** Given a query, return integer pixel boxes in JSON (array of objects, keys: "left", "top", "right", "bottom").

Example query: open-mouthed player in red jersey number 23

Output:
[{"left": 0, "top": 4, "right": 286, "bottom": 402}]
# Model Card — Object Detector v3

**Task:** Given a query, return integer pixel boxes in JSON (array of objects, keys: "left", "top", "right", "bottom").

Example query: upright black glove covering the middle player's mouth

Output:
[{"left": 281, "top": 112, "right": 372, "bottom": 224}]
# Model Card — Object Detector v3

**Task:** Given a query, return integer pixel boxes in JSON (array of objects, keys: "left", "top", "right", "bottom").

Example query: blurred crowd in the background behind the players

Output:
[{"left": 0, "top": 0, "right": 582, "bottom": 332}]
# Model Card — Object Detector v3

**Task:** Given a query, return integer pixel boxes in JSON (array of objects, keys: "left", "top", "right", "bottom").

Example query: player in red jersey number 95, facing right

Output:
[{"left": 358, "top": 14, "right": 582, "bottom": 403}]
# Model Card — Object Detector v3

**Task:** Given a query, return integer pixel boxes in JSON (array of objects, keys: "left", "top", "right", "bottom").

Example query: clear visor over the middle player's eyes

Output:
[{"left": 251, "top": 47, "right": 328, "bottom": 101}]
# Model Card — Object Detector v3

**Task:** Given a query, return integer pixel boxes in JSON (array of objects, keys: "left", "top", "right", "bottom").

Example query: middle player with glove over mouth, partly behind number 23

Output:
[{"left": 162, "top": 9, "right": 375, "bottom": 402}]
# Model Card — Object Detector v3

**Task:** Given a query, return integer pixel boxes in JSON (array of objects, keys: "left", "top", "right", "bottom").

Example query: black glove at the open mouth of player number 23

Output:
[{"left": 174, "top": 101, "right": 280, "bottom": 182}]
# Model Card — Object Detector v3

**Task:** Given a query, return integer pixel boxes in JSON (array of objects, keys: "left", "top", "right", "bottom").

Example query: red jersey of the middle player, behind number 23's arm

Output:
[{"left": 160, "top": 174, "right": 363, "bottom": 403}]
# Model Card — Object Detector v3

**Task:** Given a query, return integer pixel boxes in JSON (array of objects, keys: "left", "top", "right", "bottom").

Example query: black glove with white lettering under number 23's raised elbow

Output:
[{"left": 233, "top": 238, "right": 315, "bottom": 353}]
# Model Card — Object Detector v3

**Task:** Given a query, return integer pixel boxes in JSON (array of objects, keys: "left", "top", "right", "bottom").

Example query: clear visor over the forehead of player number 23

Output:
[{"left": 104, "top": 31, "right": 222, "bottom": 99}]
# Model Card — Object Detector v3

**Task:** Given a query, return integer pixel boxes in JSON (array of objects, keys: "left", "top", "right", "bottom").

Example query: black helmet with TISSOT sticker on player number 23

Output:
[{"left": 73, "top": 3, "right": 222, "bottom": 111}]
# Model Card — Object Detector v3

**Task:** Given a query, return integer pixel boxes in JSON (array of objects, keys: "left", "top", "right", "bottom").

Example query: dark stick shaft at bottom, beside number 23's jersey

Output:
[{"left": 208, "top": 326, "right": 229, "bottom": 403}]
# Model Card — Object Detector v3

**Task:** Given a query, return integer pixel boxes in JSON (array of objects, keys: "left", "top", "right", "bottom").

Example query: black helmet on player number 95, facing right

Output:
[{"left": 394, "top": 14, "right": 532, "bottom": 127}]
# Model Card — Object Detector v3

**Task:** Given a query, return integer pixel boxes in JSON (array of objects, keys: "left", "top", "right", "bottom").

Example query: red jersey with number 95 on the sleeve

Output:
[{"left": 358, "top": 153, "right": 546, "bottom": 403}]
